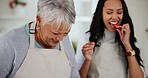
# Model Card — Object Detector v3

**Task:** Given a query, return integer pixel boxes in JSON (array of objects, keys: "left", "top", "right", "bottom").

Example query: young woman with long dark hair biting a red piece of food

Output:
[{"left": 76, "top": 0, "right": 145, "bottom": 78}]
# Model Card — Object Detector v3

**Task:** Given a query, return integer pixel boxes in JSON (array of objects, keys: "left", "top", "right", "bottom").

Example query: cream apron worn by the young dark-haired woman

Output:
[{"left": 88, "top": 40, "right": 127, "bottom": 78}]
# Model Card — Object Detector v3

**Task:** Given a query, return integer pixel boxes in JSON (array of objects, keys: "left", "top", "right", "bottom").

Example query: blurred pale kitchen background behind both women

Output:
[{"left": 0, "top": 0, "right": 148, "bottom": 76}]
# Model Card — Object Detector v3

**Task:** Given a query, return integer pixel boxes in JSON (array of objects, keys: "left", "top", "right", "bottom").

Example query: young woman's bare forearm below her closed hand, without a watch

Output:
[{"left": 79, "top": 60, "right": 91, "bottom": 78}]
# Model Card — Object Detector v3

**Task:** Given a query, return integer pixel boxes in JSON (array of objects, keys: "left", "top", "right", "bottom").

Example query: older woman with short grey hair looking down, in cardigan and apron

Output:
[{"left": 0, "top": 0, "right": 79, "bottom": 78}]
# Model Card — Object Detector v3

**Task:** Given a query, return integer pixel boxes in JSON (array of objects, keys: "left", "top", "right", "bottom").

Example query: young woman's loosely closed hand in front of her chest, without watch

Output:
[{"left": 82, "top": 42, "right": 95, "bottom": 61}]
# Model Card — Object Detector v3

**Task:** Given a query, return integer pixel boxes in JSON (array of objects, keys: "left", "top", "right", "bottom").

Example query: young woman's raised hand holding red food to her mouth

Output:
[{"left": 116, "top": 24, "right": 131, "bottom": 46}]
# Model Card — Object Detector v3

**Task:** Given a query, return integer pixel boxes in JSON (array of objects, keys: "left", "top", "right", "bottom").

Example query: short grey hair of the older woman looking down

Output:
[{"left": 37, "top": 0, "right": 76, "bottom": 27}]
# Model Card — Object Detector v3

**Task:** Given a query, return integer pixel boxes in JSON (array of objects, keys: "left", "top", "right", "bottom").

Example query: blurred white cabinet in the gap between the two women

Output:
[{"left": 69, "top": 0, "right": 98, "bottom": 43}]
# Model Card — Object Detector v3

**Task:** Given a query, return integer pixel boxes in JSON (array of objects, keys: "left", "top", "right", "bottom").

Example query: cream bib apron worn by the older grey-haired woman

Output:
[{"left": 13, "top": 23, "right": 71, "bottom": 78}]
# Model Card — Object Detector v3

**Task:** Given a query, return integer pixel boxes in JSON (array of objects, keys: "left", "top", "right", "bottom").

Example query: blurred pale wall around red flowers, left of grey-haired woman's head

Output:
[{"left": 0, "top": 0, "right": 38, "bottom": 35}]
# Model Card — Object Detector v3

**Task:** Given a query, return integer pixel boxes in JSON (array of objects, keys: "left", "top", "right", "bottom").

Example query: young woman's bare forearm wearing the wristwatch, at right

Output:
[{"left": 125, "top": 45, "right": 144, "bottom": 78}]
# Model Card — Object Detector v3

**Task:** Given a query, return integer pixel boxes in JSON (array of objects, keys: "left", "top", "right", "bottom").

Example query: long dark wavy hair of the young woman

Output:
[{"left": 88, "top": 0, "right": 143, "bottom": 66}]
